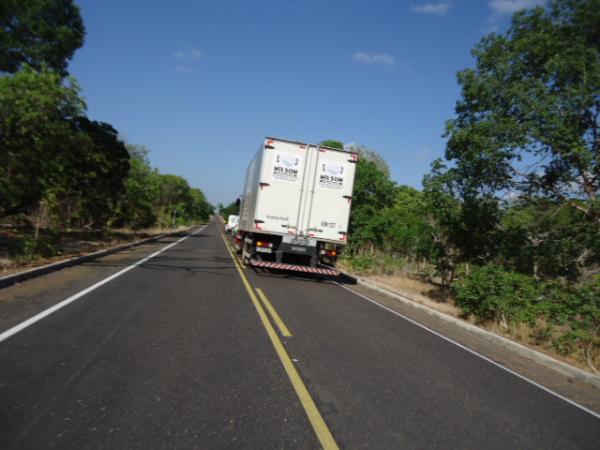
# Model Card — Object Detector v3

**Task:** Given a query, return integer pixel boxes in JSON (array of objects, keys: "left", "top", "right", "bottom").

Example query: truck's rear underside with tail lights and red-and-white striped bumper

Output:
[{"left": 235, "top": 231, "right": 341, "bottom": 276}]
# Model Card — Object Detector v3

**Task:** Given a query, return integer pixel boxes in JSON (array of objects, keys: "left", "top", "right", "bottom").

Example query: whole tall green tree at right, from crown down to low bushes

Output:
[{"left": 424, "top": 0, "right": 600, "bottom": 280}]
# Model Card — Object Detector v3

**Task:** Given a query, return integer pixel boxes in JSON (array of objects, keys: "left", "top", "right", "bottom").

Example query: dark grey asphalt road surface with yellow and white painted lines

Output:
[{"left": 0, "top": 223, "right": 600, "bottom": 449}]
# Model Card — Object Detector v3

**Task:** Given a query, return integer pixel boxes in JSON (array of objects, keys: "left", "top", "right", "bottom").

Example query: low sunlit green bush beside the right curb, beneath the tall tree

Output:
[{"left": 452, "top": 264, "right": 600, "bottom": 370}]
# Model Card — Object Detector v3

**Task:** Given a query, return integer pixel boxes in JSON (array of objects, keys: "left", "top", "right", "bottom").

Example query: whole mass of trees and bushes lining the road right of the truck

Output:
[{"left": 340, "top": 0, "right": 600, "bottom": 372}]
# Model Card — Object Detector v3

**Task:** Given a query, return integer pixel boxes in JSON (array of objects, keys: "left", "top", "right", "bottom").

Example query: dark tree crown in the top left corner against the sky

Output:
[{"left": 0, "top": 0, "right": 85, "bottom": 76}]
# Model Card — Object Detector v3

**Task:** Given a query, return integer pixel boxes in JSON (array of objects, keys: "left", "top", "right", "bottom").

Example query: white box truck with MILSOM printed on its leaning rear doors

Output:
[{"left": 236, "top": 137, "right": 358, "bottom": 275}]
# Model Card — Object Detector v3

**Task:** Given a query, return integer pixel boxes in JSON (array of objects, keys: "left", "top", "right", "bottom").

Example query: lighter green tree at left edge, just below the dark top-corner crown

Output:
[{"left": 0, "top": 67, "right": 85, "bottom": 217}]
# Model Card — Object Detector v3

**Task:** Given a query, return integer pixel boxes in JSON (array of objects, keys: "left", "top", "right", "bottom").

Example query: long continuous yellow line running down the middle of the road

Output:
[{"left": 221, "top": 235, "right": 339, "bottom": 450}]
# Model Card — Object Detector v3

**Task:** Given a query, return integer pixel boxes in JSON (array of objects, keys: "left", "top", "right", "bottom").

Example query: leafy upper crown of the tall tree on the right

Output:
[{"left": 446, "top": 0, "right": 600, "bottom": 223}]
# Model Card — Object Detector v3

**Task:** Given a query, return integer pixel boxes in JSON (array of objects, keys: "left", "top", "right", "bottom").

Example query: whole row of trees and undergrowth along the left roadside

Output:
[{"left": 0, "top": 0, "right": 212, "bottom": 268}]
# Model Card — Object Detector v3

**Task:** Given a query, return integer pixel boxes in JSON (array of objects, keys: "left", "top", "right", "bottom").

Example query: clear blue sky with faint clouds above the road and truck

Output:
[{"left": 70, "top": 0, "right": 540, "bottom": 204}]
